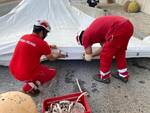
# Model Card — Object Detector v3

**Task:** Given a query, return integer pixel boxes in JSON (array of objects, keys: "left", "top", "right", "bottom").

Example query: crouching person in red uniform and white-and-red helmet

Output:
[{"left": 9, "top": 20, "right": 63, "bottom": 95}]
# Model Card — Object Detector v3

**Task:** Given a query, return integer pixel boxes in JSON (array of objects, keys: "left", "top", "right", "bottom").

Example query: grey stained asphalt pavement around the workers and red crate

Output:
[{"left": 0, "top": 2, "right": 150, "bottom": 113}]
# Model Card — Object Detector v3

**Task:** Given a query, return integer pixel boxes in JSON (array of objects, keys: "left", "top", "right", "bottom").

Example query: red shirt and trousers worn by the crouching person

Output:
[{"left": 9, "top": 34, "right": 56, "bottom": 84}]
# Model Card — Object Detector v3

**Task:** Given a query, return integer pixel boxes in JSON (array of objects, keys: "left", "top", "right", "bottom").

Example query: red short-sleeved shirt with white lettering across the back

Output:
[{"left": 10, "top": 34, "right": 50, "bottom": 77}]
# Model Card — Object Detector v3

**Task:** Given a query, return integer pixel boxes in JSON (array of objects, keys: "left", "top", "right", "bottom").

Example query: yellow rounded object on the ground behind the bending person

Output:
[{"left": 128, "top": 0, "right": 140, "bottom": 13}]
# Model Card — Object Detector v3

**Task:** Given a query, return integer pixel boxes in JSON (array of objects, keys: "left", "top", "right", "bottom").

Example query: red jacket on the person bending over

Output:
[{"left": 82, "top": 16, "right": 133, "bottom": 48}]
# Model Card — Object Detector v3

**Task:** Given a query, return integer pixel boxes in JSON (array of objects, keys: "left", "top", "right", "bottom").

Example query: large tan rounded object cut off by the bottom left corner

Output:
[{"left": 0, "top": 91, "right": 38, "bottom": 113}]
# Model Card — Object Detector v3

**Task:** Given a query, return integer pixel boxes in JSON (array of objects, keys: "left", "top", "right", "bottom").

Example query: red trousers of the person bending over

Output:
[{"left": 100, "top": 21, "right": 133, "bottom": 74}]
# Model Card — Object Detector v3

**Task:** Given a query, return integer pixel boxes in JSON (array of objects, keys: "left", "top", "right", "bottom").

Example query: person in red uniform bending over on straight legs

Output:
[{"left": 76, "top": 16, "right": 133, "bottom": 83}]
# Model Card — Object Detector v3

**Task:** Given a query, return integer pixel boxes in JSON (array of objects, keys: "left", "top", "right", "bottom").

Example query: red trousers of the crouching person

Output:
[{"left": 15, "top": 65, "right": 56, "bottom": 84}]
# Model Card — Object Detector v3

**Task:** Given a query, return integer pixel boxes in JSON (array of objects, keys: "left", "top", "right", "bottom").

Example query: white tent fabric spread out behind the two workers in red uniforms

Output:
[{"left": 0, "top": 0, "right": 150, "bottom": 66}]
